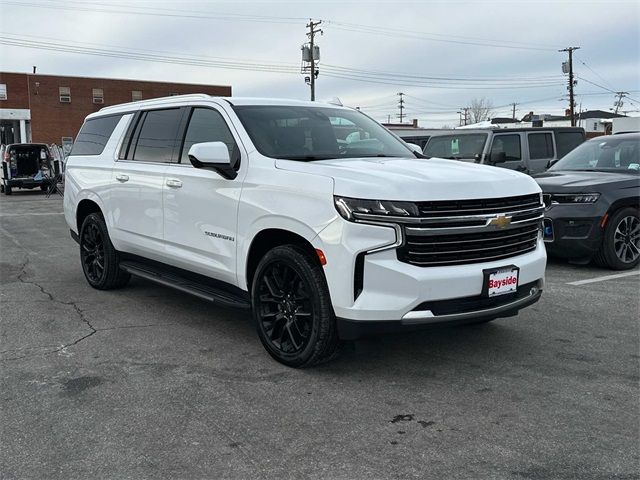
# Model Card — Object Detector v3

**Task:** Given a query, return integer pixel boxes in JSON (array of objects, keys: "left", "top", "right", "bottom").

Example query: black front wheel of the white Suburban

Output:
[{"left": 251, "top": 245, "right": 339, "bottom": 368}]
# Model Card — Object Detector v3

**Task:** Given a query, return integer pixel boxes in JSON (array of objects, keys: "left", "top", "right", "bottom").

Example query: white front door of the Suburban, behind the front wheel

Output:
[{"left": 163, "top": 106, "right": 246, "bottom": 284}]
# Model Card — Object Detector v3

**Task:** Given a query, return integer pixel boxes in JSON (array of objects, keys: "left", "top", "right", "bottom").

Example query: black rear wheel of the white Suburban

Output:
[{"left": 80, "top": 213, "right": 131, "bottom": 290}]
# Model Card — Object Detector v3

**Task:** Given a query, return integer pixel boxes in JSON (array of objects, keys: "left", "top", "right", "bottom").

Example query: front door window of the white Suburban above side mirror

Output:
[{"left": 180, "top": 108, "right": 239, "bottom": 163}]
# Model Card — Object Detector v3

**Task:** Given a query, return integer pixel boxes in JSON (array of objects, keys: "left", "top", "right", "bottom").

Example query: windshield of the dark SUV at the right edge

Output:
[{"left": 549, "top": 136, "right": 640, "bottom": 173}]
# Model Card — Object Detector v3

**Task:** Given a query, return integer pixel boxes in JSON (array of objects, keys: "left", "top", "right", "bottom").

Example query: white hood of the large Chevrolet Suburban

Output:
[{"left": 276, "top": 158, "right": 540, "bottom": 201}]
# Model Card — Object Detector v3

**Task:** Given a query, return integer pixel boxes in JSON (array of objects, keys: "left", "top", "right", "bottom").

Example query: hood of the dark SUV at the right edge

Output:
[{"left": 534, "top": 170, "right": 640, "bottom": 193}]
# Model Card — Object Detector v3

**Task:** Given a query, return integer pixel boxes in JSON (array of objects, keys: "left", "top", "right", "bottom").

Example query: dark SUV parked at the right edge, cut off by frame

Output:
[{"left": 535, "top": 133, "right": 640, "bottom": 270}]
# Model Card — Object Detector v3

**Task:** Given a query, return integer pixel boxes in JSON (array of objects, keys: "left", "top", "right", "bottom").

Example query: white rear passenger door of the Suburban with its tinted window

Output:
[{"left": 110, "top": 107, "right": 184, "bottom": 260}]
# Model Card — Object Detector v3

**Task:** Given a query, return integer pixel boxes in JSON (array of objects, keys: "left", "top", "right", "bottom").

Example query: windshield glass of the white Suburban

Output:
[{"left": 234, "top": 105, "right": 415, "bottom": 161}]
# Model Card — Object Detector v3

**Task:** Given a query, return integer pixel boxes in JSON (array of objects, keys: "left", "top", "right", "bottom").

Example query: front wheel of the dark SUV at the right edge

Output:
[{"left": 594, "top": 207, "right": 640, "bottom": 270}]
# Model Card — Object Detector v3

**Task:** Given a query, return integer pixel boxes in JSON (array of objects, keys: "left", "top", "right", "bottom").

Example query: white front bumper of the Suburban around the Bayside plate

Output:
[{"left": 314, "top": 221, "right": 546, "bottom": 338}]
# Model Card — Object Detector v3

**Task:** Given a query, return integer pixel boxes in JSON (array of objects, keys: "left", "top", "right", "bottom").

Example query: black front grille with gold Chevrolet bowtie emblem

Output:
[{"left": 397, "top": 194, "right": 544, "bottom": 267}]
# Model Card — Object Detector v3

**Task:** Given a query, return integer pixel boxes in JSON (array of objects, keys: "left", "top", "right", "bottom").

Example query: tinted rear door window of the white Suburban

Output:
[{"left": 133, "top": 108, "right": 182, "bottom": 162}]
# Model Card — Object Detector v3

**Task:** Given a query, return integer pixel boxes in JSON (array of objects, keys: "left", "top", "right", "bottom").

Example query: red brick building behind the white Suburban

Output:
[{"left": 0, "top": 72, "right": 231, "bottom": 145}]
